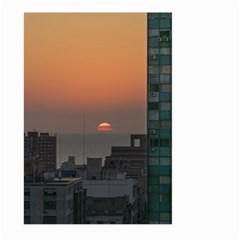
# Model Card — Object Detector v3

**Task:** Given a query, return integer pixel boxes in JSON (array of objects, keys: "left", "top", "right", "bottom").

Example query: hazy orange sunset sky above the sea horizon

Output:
[{"left": 24, "top": 13, "right": 147, "bottom": 133}]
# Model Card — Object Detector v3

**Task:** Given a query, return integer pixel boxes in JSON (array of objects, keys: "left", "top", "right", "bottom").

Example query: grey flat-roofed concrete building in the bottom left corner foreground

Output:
[{"left": 24, "top": 178, "right": 86, "bottom": 224}]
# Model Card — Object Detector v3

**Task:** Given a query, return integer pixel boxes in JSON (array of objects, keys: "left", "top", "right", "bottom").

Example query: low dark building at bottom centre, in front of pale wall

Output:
[{"left": 87, "top": 195, "right": 131, "bottom": 224}]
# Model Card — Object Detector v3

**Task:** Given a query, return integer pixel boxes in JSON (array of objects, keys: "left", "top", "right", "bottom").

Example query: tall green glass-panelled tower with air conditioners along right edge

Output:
[{"left": 147, "top": 13, "right": 172, "bottom": 224}]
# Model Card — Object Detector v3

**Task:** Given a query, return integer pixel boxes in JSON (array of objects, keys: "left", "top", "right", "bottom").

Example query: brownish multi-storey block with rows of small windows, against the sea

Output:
[{"left": 24, "top": 131, "right": 57, "bottom": 181}]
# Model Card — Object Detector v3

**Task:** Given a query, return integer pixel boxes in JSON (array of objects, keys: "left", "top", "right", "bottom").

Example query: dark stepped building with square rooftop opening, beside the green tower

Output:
[{"left": 102, "top": 134, "right": 147, "bottom": 223}]
